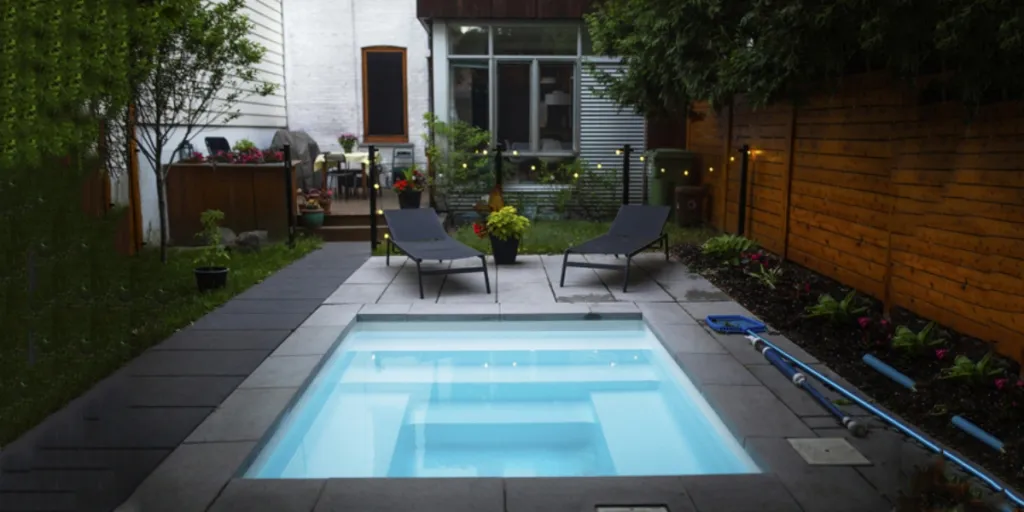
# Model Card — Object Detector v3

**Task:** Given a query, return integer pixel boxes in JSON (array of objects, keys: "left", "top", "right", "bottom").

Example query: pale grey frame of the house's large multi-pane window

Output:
[{"left": 445, "top": 19, "right": 586, "bottom": 158}]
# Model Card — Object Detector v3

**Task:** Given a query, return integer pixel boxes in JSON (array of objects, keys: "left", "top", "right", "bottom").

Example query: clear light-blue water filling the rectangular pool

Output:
[{"left": 246, "top": 321, "right": 759, "bottom": 478}]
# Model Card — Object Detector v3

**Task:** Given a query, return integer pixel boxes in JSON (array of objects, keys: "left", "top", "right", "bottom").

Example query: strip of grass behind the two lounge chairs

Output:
[{"left": 375, "top": 220, "right": 715, "bottom": 256}]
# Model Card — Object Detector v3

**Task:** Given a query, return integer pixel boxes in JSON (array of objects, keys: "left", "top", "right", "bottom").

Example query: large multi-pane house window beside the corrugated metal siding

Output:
[{"left": 447, "top": 24, "right": 582, "bottom": 181}]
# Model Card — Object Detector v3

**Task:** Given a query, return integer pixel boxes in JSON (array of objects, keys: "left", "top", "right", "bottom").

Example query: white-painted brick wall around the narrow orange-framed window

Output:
[{"left": 284, "top": 0, "right": 430, "bottom": 160}]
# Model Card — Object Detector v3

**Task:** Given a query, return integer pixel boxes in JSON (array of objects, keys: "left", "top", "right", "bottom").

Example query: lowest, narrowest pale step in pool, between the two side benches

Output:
[{"left": 407, "top": 401, "right": 594, "bottom": 425}]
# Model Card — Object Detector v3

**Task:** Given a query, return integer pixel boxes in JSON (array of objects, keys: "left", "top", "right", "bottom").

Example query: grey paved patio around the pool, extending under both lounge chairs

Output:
[{"left": 112, "top": 254, "right": 950, "bottom": 512}]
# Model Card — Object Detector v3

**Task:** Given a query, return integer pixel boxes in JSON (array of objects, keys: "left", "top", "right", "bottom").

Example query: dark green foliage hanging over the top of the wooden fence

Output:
[{"left": 586, "top": 0, "right": 1024, "bottom": 114}]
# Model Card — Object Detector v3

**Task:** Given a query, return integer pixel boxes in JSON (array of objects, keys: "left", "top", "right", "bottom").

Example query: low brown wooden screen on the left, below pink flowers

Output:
[{"left": 167, "top": 161, "right": 299, "bottom": 246}]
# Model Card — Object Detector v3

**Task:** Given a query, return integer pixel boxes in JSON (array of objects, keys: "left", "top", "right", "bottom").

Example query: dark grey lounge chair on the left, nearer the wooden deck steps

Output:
[{"left": 384, "top": 208, "right": 490, "bottom": 299}]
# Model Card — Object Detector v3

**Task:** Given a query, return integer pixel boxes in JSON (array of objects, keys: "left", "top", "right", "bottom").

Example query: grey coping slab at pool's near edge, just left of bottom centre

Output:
[{"left": 313, "top": 478, "right": 503, "bottom": 512}]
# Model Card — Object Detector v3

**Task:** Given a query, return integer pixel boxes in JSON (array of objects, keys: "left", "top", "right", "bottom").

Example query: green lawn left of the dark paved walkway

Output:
[{"left": 0, "top": 238, "right": 322, "bottom": 446}]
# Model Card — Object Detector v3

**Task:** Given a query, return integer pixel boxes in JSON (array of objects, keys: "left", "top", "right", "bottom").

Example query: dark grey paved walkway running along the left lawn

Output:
[{"left": 0, "top": 244, "right": 370, "bottom": 512}]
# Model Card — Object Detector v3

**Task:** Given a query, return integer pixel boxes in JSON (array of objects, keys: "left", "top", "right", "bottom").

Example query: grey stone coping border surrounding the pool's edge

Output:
[{"left": 118, "top": 303, "right": 913, "bottom": 512}]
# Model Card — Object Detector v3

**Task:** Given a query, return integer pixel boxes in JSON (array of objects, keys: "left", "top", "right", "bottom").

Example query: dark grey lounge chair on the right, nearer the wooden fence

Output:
[{"left": 558, "top": 205, "right": 671, "bottom": 293}]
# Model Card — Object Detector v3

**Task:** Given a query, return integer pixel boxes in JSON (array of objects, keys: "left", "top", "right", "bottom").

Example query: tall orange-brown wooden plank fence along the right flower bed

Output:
[{"left": 688, "top": 76, "right": 1024, "bottom": 360}]
